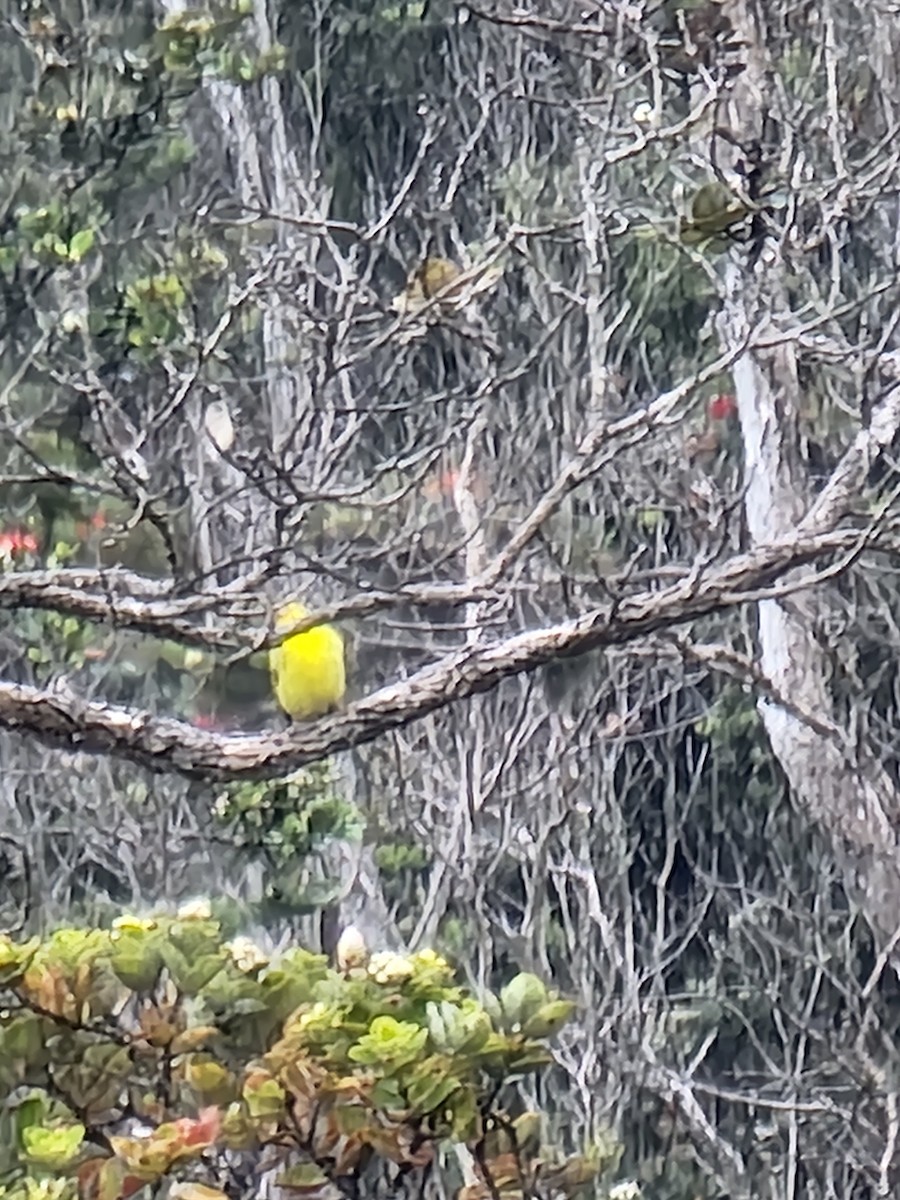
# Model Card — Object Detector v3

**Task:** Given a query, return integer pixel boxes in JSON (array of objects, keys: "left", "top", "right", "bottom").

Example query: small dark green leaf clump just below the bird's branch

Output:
[{"left": 214, "top": 761, "right": 362, "bottom": 865}]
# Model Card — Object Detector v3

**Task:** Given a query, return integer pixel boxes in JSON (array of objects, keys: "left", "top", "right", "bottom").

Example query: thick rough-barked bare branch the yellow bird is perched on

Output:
[{"left": 0, "top": 529, "right": 892, "bottom": 779}]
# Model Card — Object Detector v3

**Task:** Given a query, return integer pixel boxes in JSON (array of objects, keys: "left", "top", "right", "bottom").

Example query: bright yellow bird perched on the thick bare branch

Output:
[{"left": 269, "top": 600, "right": 347, "bottom": 720}]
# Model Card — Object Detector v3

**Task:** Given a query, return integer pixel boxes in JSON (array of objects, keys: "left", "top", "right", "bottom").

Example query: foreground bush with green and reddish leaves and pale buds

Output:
[{"left": 0, "top": 901, "right": 601, "bottom": 1200}]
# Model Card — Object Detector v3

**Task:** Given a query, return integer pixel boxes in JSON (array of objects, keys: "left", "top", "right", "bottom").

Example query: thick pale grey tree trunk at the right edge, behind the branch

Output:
[{"left": 719, "top": 0, "right": 900, "bottom": 944}]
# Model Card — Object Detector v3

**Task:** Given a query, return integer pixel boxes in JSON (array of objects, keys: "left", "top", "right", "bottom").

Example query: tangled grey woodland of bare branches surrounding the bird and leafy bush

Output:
[{"left": 0, "top": 0, "right": 900, "bottom": 1200}]
